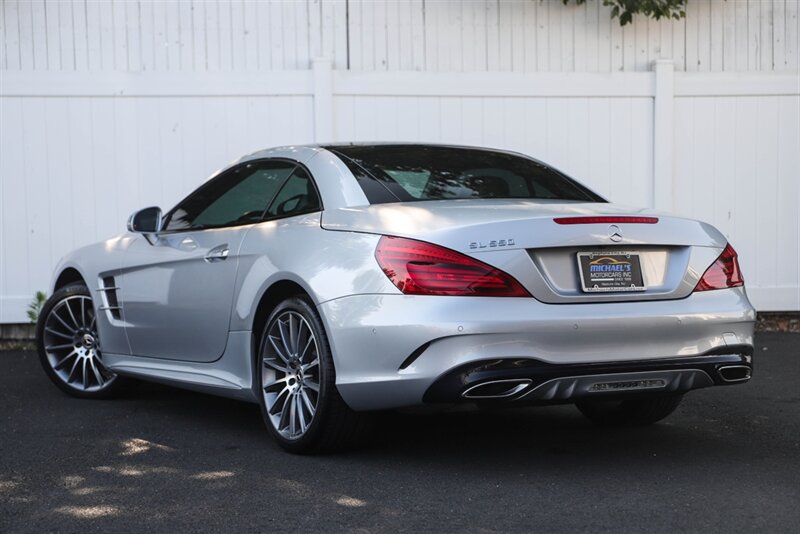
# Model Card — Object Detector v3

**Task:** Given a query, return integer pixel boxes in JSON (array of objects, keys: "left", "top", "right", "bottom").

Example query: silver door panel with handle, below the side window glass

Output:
[{"left": 119, "top": 226, "right": 247, "bottom": 362}]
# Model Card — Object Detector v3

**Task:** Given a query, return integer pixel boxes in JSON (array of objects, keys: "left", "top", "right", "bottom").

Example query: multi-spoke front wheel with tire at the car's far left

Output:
[{"left": 36, "top": 284, "right": 124, "bottom": 399}]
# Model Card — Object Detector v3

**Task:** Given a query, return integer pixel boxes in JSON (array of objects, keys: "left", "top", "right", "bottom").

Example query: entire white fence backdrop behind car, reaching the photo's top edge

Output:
[{"left": 0, "top": 0, "right": 800, "bottom": 323}]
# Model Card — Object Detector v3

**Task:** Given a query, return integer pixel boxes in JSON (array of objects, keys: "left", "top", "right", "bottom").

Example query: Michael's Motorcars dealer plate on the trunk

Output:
[{"left": 578, "top": 251, "right": 646, "bottom": 293}]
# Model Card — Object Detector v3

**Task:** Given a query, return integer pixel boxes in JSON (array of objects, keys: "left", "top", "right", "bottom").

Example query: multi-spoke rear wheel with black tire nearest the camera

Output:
[{"left": 256, "top": 297, "right": 369, "bottom": 454}]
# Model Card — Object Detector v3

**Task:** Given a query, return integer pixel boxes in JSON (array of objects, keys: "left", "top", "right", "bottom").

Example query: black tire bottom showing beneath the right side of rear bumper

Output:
[{"left": 575, "top": 393, "right": 683, "bottom": 426}]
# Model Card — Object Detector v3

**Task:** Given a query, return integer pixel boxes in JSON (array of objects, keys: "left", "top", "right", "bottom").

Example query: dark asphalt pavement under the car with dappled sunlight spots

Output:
[{"left": 0, "top": 334, "right": 800, "bottom": 532}]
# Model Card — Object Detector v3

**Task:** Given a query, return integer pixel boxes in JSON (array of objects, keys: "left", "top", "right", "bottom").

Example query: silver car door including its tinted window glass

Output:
[{"left": 117, "top": 160, "right": 296, "bottom": 362}]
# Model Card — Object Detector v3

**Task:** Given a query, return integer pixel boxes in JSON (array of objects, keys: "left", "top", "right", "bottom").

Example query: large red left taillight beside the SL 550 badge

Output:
[{"left": 375, "top": 236, "right": 530, "bottom": 297}]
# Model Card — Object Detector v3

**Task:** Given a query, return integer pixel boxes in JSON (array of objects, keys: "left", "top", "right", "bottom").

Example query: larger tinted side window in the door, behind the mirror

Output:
[{"left": 164, "top": 161, "right": 295, "bottom": 231}]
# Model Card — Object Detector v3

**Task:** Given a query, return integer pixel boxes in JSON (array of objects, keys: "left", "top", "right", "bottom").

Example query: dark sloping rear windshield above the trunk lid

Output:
[{"left": 327, "top": 145, "right": 605, "bottom": 204}]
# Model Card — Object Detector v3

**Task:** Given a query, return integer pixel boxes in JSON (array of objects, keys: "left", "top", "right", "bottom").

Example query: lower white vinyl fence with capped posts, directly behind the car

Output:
[{"left": 0, "top": 60, "right": 800, "bottom": 322}]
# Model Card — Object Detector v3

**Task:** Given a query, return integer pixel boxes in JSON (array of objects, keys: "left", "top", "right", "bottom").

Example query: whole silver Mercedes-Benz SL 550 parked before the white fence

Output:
[{"left": 37, "top": 144, "right": 755, "bottom": 452}]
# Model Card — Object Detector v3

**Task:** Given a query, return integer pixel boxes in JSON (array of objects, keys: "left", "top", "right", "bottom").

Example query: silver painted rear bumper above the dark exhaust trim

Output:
[{"left": 319, "top": 288, "right": 755, "bottom": 410}]
